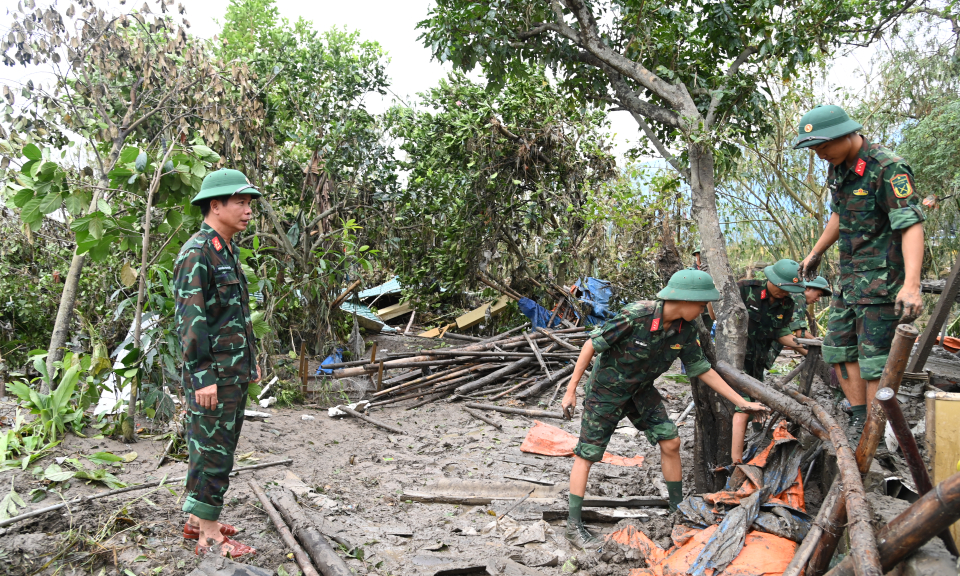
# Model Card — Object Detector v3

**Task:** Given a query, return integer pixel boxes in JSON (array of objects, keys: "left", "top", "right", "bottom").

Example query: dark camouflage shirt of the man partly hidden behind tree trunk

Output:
[{"left": 737, "top": 280, "right": 803, "bottom": 368}]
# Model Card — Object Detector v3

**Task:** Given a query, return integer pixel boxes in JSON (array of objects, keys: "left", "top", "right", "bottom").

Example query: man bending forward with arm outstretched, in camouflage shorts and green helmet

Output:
[{"left": 563, "top": 270, "right": 767, "bottom": 548}]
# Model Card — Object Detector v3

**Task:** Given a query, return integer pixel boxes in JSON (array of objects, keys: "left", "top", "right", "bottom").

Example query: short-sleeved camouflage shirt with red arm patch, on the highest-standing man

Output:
[{"left": 827, "top": 138, "right": 924, "bottom": 304}]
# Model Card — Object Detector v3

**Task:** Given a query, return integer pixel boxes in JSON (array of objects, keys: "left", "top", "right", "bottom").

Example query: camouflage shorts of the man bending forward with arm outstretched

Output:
[{"left": 573, "top": 385, "right": 680, "bottom": 462}]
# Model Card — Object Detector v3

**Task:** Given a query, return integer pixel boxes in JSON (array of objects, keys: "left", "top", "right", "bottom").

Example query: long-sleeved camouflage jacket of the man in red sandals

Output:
[{"left": 173, "top": 223, "right": 257, "bottom": 390}]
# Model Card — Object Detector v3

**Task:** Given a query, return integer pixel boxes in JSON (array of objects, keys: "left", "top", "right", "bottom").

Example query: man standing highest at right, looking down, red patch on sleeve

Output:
[{"left": 794, "top": 106, "right": 924, "bottom": 443}]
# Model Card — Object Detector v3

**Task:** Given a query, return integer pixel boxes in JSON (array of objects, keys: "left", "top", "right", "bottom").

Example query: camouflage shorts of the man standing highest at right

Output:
[{"left": 823, "top": 295, "right": 900, "bottom": 380}]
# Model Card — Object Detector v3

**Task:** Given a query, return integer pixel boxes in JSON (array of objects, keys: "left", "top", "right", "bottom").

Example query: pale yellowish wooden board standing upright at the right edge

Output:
[{"left": 925, "top": 391, "right": 960, "bottom": 542}]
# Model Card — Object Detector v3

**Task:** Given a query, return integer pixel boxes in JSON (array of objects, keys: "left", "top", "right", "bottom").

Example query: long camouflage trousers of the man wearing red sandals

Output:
[{"left": 183, "top": 384, "right": 247, "bottom": 520}]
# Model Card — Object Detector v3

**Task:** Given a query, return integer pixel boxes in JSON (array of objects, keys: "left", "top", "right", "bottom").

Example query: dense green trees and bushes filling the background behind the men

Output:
[{"left": 0, "top": 0, "right": 960, "bottom": 456}]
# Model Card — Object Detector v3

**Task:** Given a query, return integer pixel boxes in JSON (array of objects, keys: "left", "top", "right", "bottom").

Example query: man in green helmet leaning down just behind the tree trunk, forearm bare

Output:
[{"left": 730, "top": 258, "right": 807, "bottom": 462}]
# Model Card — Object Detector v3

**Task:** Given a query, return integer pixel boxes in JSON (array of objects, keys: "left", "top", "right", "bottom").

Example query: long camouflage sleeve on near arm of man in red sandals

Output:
[{"left": 174, "top": 249, "right": 218, "bottom": 390}]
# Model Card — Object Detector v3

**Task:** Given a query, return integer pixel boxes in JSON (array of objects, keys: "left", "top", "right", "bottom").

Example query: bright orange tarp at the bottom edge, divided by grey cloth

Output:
[{"left": 608, "top": 525, "right": 797, "bottom": 576}]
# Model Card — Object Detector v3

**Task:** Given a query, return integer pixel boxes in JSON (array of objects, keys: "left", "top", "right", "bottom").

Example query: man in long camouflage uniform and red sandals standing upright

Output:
[{"left": 174, "top": 169, "right": 261, "bottom": 558}]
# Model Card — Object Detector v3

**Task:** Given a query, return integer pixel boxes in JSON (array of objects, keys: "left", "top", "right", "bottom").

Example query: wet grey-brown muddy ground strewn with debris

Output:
[{"left": 0, "top": 337, "right": 928, "bottom": 576}]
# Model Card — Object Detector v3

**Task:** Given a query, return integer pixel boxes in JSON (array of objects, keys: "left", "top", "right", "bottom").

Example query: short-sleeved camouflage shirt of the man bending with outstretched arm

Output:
[{"left": 590, "top": 300, "right": 710, "bottom": 391}]
